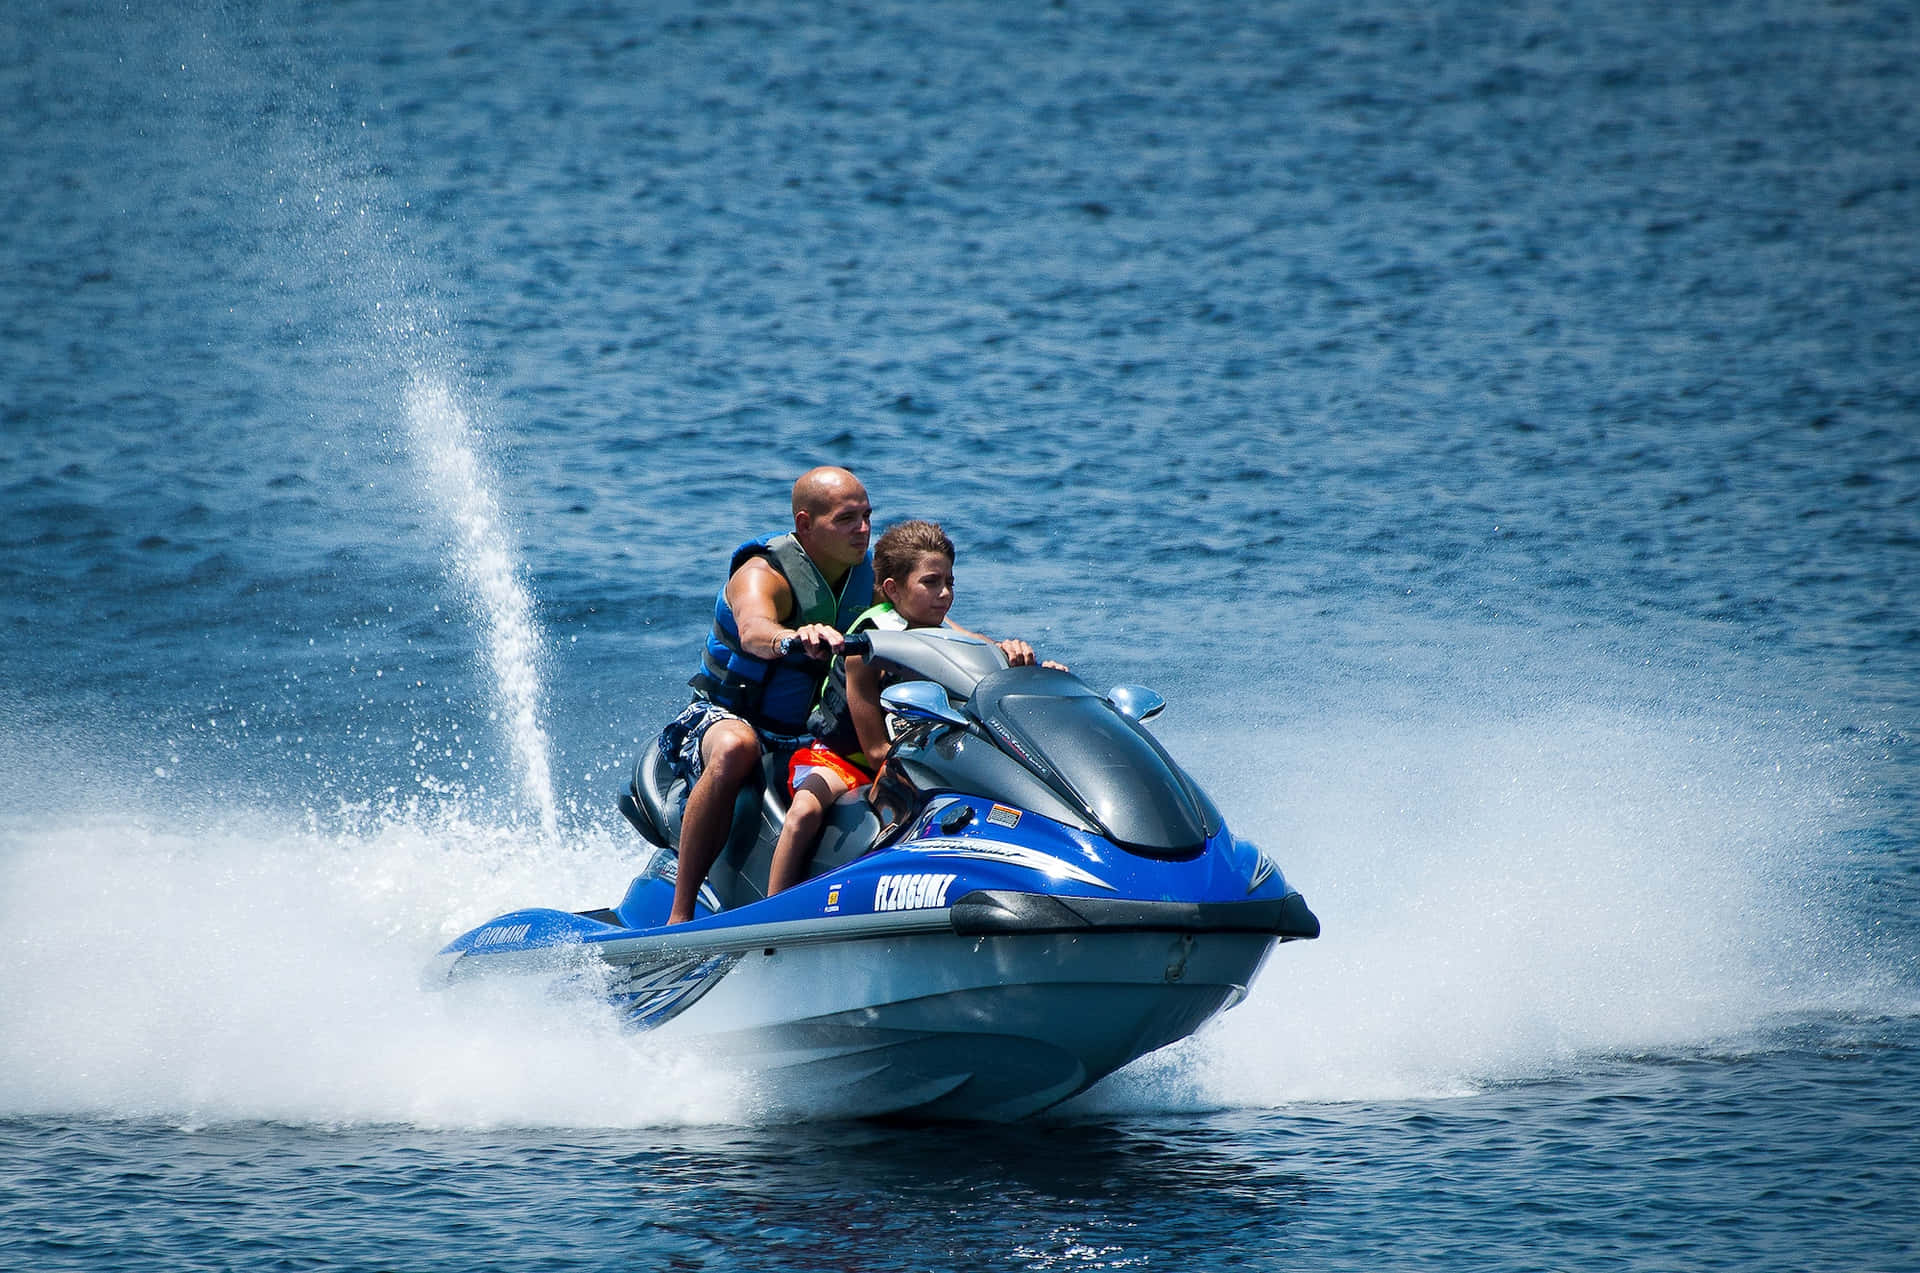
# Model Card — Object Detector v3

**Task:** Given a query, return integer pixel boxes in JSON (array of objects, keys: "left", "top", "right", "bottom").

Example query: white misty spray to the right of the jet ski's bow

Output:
[{"left": 1083, "top": 709, "right": 1914, "bottom": 1110}]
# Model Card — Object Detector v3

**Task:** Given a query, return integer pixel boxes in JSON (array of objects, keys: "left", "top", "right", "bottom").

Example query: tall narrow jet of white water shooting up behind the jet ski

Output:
[{"left": 407, "top": 376, "right": 559, "bottom": 843}]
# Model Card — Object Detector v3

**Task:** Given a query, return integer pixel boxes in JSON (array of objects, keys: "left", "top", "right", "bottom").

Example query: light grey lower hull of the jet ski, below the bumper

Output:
[{"left": 634, "top": 933, "right": 1273, "bottom": 1121}]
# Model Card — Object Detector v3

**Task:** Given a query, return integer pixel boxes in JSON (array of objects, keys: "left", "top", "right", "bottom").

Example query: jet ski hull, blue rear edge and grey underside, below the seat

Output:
[{"left": 440, "top": 854, "right": 1317, "bottom": 1121}]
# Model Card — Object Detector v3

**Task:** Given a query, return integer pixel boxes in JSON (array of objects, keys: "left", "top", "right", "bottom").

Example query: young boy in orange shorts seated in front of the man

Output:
[{"left": 766, "top": 520, "right": 1058, "bottom": 897}]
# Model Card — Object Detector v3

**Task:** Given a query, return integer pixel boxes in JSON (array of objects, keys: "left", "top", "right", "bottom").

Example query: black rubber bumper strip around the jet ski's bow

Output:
[{"left": 952, "top": 889, "right": 1319, "bottom": 941}]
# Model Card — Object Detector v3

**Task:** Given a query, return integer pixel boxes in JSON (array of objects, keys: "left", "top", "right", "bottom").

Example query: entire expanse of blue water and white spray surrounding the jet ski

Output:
[{"left": 0, "top": 2, "right": 1920, "bottom": 1269}]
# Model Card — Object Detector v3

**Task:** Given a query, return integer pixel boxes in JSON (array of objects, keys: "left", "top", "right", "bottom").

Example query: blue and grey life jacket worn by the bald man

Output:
[{"left": 687, "top": 532, "right": 874, "bottom": 737}]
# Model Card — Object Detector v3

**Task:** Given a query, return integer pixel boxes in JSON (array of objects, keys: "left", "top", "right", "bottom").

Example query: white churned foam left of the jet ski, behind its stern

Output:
[{"left": 0, "top": 810, "right": 741, "bottom": 1127}]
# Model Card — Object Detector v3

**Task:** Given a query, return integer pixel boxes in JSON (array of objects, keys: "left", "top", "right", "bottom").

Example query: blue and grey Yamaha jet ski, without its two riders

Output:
[{"left": 430, "top": 628, "right": 1319, "bottom": 1121}]
